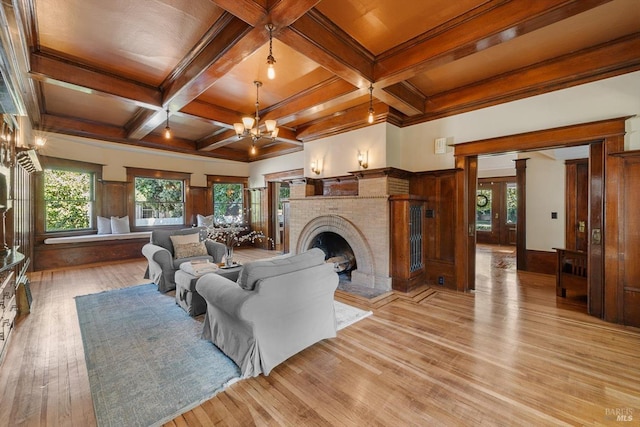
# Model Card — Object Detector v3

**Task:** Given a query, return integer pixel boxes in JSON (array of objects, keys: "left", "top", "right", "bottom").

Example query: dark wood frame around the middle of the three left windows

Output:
[{"left": 126, "top": 167, "right": 191, "bottom": 231}]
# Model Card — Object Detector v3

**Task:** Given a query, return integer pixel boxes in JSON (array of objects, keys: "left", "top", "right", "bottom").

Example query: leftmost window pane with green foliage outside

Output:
[{"left": 43, "top": 169, "right": 95, "bottom": 232}]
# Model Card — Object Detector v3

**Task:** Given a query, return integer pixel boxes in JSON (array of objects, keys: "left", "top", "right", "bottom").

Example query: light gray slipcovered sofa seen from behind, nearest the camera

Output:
[{"left": 196, "top": 248, "right": 338, "bottom": 377}]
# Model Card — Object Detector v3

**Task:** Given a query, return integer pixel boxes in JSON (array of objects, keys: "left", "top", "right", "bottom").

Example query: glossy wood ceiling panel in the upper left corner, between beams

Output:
[{"left": 35, "top": 0, "right": 224, "bottom": 86}]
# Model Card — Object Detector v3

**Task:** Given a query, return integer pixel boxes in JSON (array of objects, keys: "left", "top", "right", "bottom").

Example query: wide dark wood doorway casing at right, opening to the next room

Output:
[{"left": 454, "top": 117, "right": 628, "bottom": 322}]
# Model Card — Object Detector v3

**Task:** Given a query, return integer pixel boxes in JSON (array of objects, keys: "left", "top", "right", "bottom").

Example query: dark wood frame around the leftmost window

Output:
[{"left": 35, "top": 156, "right": 102, "bottom": 236}]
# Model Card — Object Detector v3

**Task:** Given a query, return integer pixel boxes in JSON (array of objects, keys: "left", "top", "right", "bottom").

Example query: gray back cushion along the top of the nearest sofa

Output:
[{"left": 237, "top": 248, "right": 324, "bottom": 291}]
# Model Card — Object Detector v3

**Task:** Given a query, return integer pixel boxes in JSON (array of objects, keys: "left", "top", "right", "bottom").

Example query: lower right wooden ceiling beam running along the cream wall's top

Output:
[{"left": 416, "top": 33, "right": 640, "bottom": 125}]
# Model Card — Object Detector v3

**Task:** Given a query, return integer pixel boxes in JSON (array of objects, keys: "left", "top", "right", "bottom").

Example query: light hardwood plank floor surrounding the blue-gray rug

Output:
[{"left": 0, "top": 247, "right": 640, "bottom": 426}]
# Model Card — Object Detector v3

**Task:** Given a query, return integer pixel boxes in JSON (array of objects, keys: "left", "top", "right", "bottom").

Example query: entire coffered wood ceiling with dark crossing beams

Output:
[{"left": 5, "top": 0, "right": 640, "bottom": 161}]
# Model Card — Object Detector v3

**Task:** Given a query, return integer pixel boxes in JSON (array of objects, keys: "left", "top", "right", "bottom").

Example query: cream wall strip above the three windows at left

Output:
[{"left": 32, "top": 133, "right": 249, "bottom": 187}]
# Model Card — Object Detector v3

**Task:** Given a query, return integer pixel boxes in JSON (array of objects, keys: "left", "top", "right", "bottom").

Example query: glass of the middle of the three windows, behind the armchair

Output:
[{"left": 134, "top": 176, "right": 185, "bottom": 227}]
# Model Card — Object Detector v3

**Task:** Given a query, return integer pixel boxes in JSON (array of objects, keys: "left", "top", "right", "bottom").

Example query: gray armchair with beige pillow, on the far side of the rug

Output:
[{"left": 142, "top": 227, "right": 225, "bottom": 293}]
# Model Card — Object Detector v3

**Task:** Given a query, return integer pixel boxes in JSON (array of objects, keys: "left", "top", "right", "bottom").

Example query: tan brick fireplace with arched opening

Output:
[{"left": 289, "top": 169, "right": 409, "bottom": 290}]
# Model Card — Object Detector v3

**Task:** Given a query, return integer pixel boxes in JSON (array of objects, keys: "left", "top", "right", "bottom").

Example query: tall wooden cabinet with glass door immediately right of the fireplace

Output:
[{"left": 389, "top": 194, "right": 426, "bottom": 292}]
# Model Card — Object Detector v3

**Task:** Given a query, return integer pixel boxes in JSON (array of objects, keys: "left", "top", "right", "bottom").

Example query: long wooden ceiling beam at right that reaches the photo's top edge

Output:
[{"left": 373, "top": 0, "right": 611, "bottom": 87}]
